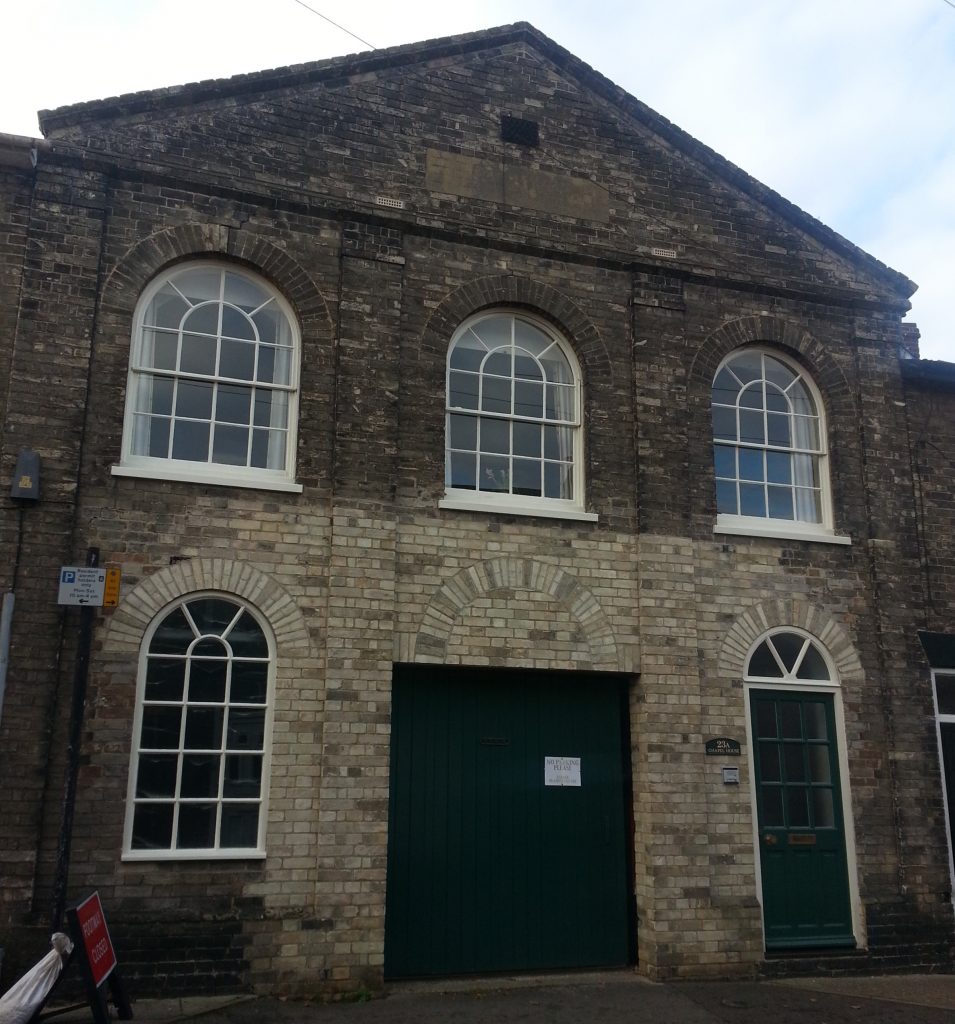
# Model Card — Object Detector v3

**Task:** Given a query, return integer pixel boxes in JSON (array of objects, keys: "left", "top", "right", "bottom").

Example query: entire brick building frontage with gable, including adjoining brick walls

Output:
[{"left": 0, "top": 24, "right": 955, "bottom": 995}]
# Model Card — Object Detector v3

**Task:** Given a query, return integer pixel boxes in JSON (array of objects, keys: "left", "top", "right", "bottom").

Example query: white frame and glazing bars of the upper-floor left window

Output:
[{"left": 112, "top": 260, "right": 302, "bottom": 494}]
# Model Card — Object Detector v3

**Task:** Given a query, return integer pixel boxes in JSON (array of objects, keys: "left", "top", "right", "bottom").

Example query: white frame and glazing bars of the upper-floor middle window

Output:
[{"left": 438, "top": 307, "right": 597, "bottom": 522}]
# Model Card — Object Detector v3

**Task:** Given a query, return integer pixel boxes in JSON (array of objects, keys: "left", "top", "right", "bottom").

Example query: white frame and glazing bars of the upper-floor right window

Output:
[{"left": 710, "top": 345, "right": 852, "bottom": 545}]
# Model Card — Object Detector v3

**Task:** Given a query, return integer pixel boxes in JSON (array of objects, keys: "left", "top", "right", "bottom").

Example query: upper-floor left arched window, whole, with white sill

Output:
[{"left": 114, "top": 262, "right": 300, "bottom": 489}]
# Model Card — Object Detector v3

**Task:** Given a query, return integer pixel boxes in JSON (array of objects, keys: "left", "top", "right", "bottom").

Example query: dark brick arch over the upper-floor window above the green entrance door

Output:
[{"left": 690, "top": 316, "right": 855, "bottom": 422}]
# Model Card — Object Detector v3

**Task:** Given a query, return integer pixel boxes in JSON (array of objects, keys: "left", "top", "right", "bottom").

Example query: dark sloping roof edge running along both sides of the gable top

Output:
[{"left": 39, "top": 22, "right": 918, "bottom": 299}]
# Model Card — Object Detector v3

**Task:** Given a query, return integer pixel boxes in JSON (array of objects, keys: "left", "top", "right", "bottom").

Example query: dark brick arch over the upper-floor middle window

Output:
[{"left": 425, "top": 274, "right": 613, "bottom": 381}]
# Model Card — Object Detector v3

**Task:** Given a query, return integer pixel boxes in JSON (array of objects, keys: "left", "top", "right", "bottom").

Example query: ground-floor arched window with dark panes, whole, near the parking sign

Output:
[{"left": 124, "top": 595, "right": 274, "bottom": 859}]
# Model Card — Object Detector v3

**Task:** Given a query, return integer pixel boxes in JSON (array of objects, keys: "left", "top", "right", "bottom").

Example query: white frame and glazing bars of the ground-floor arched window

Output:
[{"left": 122, "top": 591, "right": 275, "bottom": 861}]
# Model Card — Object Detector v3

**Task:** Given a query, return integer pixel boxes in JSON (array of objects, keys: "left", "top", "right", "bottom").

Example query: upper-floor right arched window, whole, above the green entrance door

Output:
[{"left": 712, "top": 348, "right": 848, "bottom": 543}]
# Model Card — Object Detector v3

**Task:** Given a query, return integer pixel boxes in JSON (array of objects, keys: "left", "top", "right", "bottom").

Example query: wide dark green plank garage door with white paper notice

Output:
[{"left": 385, "top": 666, "right": 633, "bottom": 978}]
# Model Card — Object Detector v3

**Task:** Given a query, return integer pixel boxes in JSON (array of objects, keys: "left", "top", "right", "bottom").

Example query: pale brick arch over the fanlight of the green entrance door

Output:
[{"left": 719, "top": 598, "right": 864, "bottom": 683}]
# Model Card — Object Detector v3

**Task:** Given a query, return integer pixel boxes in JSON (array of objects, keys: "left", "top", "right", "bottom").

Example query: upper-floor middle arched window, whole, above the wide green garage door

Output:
[{"left": 442, "top": 310, "right": 594, "bottom": 518}]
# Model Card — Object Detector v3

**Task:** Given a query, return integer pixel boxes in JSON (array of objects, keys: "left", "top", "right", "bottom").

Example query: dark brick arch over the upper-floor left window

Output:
[{"left": 102, "top": 223, "right": 333, "bottom": 327}]
